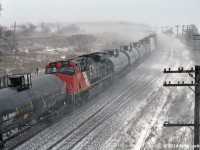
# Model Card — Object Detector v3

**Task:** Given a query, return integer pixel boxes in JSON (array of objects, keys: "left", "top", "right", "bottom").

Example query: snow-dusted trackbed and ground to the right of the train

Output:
[{"left": 17, "top": 35, "right": 200, "bottom": 150}]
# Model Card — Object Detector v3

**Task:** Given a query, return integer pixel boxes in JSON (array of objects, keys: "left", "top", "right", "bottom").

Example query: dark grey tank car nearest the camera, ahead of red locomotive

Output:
[{"left": 0, "top": 74, "right": 66, "bottom": 148}]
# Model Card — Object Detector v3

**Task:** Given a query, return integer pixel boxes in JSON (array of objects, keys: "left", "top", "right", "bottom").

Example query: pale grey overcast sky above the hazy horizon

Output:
[{"left": 0, "top": 0, "right": 200, "bottom": 26}]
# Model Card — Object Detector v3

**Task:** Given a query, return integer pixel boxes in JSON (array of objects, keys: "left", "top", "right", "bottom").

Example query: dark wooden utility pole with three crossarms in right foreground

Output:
[{"left": 163, "top": 66, "right": 200, "bottom": 150}]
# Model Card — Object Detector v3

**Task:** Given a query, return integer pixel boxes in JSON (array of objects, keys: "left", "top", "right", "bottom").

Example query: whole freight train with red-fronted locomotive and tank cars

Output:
[{"left": 0, "top": 34, "right": 157, "bottom": 146}]
